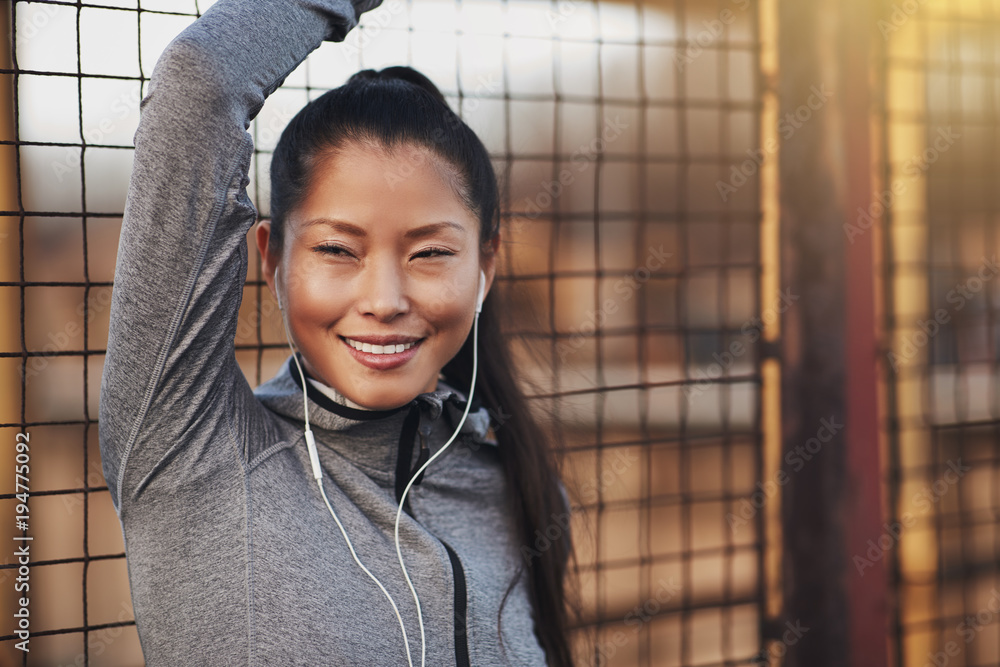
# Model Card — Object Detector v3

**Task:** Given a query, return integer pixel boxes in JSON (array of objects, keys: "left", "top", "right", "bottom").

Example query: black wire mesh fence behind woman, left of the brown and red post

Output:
[{"left": 0, "top": 0, "right": 764, "bottom": 666}]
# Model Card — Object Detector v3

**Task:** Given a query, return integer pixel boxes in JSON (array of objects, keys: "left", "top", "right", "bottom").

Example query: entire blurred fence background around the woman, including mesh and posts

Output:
[{"left": 0, "top": 0, "right": 1000, "bottom": 666}]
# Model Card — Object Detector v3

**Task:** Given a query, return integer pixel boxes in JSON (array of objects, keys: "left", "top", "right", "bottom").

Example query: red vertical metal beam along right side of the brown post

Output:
[{"left": 841, "top": 0, "right": 898, "bottom": 667}]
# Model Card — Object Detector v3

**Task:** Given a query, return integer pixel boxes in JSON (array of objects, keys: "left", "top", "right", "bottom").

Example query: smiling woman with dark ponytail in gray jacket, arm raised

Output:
[{"left": 100, "top": 0, "right": 572, "bottom": 667}]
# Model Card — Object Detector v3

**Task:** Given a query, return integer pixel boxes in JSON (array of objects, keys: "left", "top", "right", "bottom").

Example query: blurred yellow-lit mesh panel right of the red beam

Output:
[{"left": 884, "top": 0, "right": 1000, "bottom": 665}]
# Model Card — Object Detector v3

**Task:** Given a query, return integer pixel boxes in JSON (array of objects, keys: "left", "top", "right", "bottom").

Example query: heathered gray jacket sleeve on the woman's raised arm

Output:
[{"left": 99, "top": 0, "right": 381, "bottom": 514}]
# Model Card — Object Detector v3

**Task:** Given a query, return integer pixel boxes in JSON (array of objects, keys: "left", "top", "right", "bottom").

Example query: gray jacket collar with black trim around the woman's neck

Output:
[{"left": 254, "top": 356, "right": 497, "bottom": 480}]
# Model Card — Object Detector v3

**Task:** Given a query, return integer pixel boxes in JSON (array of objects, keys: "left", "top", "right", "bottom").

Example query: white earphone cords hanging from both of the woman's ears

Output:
[{"left": 274, "top": 268, "right": 485, "bottom": 667}]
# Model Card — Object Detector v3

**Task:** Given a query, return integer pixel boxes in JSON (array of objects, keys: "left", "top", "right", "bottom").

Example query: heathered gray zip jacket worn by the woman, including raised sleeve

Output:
[{"left": 100, "top": 0, "right": 545, "bottom": 667}]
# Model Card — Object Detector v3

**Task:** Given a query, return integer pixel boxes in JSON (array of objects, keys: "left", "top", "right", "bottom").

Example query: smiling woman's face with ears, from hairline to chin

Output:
[{"left": 257, "top": 143, "right": 499, "bottom": 410}]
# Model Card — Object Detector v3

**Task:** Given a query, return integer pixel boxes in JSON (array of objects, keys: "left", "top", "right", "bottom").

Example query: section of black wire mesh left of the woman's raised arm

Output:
[{"left": 0, "top": 2, "right": 211, "bottom": 665}]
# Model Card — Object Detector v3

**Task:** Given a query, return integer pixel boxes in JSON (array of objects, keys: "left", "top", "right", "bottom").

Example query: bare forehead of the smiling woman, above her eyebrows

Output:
[{"left": 294, "top": 142, "right": 478, "bottom": 233}]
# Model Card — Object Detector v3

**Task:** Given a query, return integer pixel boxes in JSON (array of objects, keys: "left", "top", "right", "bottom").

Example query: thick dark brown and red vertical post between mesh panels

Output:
[{"left": 772, "top": 0, "right": 887, "bottom": 667}]
